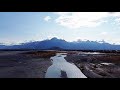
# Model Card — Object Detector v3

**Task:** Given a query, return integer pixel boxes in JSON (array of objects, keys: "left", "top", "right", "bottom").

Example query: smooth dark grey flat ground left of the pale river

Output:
[{"left": 0, "top": 51, "right": 53, "bottom": 78}]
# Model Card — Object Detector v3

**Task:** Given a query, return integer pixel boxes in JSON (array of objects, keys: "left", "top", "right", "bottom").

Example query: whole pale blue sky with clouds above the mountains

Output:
[{"left": 0, "top": 12, "right": 120, "bottom": 44}]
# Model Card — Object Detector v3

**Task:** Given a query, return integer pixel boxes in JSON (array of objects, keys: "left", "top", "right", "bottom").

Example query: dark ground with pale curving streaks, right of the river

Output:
[{"left": 65, "top": 53, "right": 120, "bottom": 78}]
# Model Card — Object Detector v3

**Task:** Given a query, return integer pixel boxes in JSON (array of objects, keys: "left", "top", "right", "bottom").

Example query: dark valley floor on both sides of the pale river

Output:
[{"left": 0, "top": 51, "right": 120, "bottom": 78}]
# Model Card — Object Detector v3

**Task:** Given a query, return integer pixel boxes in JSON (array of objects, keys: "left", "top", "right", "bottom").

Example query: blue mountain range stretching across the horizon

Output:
[{"left": 0, "top": 37, "right": 120, "bottom": 50}]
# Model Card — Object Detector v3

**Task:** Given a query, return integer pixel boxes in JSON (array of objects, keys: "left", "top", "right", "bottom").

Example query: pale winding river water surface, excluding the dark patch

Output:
[{"left": 45, "top": 53, "right": 87, "bottom": 78}]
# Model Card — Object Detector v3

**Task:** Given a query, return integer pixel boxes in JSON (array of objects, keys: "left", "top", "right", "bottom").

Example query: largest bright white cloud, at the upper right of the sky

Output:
[{"left": 55, "top": 12, "right": 120, "bottom": 29}]
